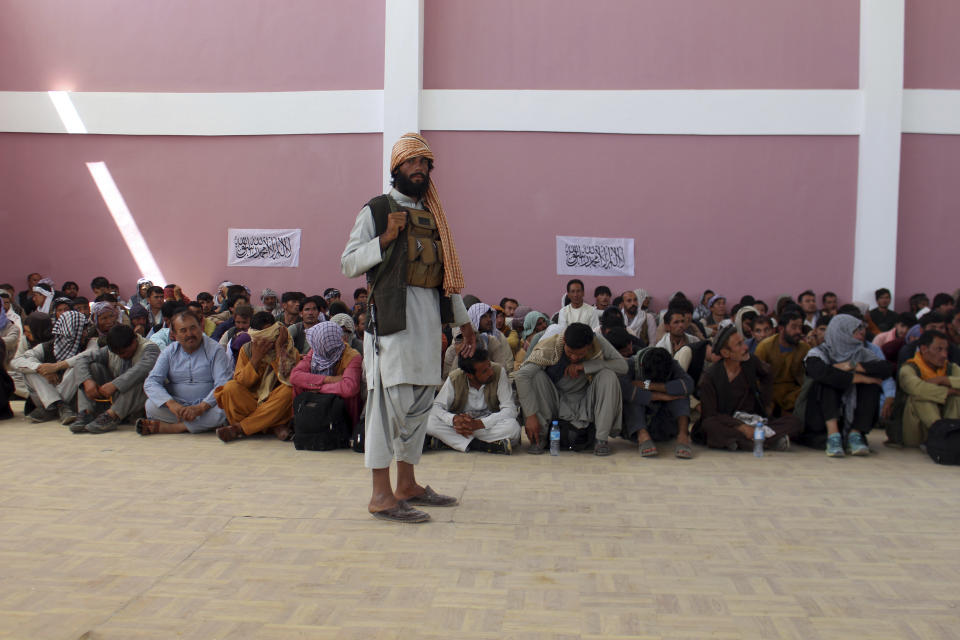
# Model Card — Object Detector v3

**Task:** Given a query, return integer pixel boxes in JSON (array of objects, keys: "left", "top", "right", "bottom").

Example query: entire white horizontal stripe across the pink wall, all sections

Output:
[{"left": 0, "top": 87, "right": 960, "bottom": 139}]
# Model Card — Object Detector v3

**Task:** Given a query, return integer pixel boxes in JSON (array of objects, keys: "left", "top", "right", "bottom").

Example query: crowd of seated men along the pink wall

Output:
[{"left": 0, "top": 273, "right": 960, "bottom": 459}]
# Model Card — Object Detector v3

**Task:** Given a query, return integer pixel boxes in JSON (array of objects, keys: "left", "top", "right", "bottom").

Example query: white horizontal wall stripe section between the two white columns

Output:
[{"left": 421, "top": 90, "right": 862, "bottom": 135}]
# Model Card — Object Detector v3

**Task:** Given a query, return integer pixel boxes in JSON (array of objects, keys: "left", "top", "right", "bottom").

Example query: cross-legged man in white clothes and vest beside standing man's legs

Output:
[{"left": 427, "top": 348, "right": 520, "bottom": 455}]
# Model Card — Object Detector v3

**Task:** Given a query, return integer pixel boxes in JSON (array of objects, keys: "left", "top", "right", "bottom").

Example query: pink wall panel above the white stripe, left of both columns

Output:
[{"left": 0, "top": 0, "right": 384, "bottom": 92}]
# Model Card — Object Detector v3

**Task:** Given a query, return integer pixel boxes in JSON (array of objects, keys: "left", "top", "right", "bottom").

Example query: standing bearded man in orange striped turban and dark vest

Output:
[{"left": 340, "top": 133, "right": 476, "bottom": 522}]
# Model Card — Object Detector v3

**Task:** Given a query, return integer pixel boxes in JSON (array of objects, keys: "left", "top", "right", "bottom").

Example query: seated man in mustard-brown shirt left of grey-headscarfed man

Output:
[{"left": 754, "top": 310, "right": 810, "bottom": 415}]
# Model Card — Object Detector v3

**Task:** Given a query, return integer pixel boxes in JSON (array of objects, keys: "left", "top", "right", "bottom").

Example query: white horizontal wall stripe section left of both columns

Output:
[{"left": 0, "top": 90, "right": 383, "bottom": 136}]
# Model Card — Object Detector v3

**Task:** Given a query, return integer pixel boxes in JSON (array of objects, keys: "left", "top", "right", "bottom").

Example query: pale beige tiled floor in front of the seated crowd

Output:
[{"left": 0, "top": 410, "right": 960, "bottom": 640}]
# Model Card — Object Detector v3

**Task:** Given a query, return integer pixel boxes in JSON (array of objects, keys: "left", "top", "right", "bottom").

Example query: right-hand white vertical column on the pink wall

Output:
[{"left": 853, "top": 0, "right": 905, "bottom": 303}]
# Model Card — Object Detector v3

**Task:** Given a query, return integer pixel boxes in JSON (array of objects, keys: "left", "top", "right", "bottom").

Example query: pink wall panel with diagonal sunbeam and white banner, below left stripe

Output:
[{"left": 0, "top": 134, "right": 381, "bottom": 297}]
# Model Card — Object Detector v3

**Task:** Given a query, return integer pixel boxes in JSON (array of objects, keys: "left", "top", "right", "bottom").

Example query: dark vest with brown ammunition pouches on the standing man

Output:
[{"left": 366, "top": 195, "right": 453, "bottom": 336}]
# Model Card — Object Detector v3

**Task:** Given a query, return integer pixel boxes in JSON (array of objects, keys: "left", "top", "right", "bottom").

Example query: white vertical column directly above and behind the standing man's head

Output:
[{"left": 383, "top": 0, "right": 423, "bottom": 187}]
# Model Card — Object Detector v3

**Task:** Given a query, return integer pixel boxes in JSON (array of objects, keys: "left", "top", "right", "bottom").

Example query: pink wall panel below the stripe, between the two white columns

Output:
[{"left": 425, "top": 132, "right": 857, "bottom": 313}]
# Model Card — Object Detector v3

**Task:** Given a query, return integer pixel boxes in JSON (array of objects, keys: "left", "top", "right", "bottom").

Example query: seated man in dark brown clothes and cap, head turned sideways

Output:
[{"left": 697, "top": 320, "right": 802, "bottom": 451}]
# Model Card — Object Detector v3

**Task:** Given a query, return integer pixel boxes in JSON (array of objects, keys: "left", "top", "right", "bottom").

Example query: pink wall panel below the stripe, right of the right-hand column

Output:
[{"left": 897, "top": 134, "right": 960, "bottom": 309}]
